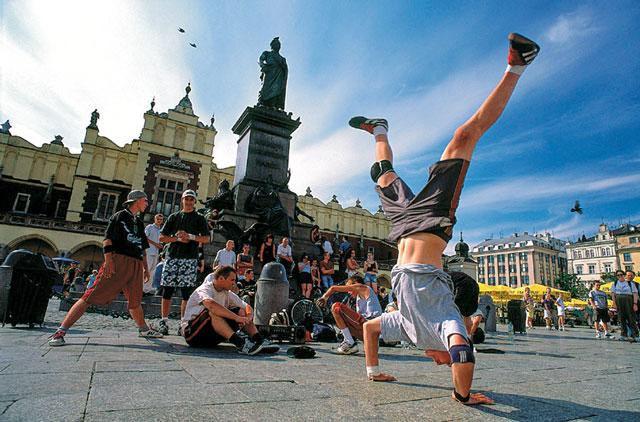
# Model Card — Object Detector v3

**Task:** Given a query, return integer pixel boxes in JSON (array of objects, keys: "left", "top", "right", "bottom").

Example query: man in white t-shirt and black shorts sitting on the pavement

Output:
[{"left": 181, "top": 266, "right": 264, "bottom": 355}]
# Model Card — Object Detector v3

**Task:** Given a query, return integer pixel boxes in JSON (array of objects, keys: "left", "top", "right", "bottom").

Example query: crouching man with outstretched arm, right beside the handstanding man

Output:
[{"left": 317, "top": 274, "right": 382, "bottom": 355}]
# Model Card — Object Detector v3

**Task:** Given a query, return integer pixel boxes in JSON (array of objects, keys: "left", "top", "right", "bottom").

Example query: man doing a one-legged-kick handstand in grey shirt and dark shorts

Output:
[{"left": 356, "top": 33, "right": 540, "bottom": 405}]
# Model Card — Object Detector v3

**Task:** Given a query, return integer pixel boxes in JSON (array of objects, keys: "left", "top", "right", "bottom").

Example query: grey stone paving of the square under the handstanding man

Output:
[{"left": 0, "top": 300, "right": 640, "bottom": 421}]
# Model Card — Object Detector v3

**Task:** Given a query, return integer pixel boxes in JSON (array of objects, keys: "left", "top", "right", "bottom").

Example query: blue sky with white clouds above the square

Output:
[{"left": 0, "top": 1, "right": 640, "bottom": 251}]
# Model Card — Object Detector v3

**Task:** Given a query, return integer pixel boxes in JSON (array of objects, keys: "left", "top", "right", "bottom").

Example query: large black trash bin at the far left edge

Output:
[{"left": 0, "top": 249, "right": 58, "bottom": 328}]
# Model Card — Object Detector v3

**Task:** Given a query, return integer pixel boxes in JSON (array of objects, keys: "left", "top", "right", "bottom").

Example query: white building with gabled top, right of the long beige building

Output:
[{"left": 566, "top": 223, "right": 620, "bottom": 283}]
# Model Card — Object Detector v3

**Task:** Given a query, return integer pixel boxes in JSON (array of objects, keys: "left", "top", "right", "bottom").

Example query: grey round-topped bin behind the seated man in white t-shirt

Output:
[{"left": 253, "top": 262, "right": 289, "bottom": 325}]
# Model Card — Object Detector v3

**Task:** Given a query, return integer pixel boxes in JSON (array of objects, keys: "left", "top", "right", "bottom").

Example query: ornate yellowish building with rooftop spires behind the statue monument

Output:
[{"left": 0, "top": 86, "right": 397, "bottom": 268}]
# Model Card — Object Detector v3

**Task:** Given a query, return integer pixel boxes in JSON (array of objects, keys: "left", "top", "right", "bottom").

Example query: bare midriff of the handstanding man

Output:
[{"left": 398, "top": 233, "right": 447, "bottom": 268}]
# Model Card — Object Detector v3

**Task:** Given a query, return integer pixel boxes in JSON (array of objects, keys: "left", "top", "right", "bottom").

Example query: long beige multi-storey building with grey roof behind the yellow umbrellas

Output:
[{"left": 472, "top": 232, "right": 567, "bottom": 287}]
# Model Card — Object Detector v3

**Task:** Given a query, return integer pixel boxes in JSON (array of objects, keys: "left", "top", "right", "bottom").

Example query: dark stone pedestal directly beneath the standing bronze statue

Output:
[{"left": 232, "top": 107, "right": 300, "bottom": 217}]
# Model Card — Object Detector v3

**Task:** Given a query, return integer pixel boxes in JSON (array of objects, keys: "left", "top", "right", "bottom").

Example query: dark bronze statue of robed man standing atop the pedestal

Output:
[{"left": 258, "top": 37, "right": 289, "bottom": 110}]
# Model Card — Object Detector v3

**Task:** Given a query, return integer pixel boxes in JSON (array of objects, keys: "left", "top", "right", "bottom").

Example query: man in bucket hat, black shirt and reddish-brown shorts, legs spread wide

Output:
[{"left": 49, "top": 190, "right": 162, "bottom": 346}]
